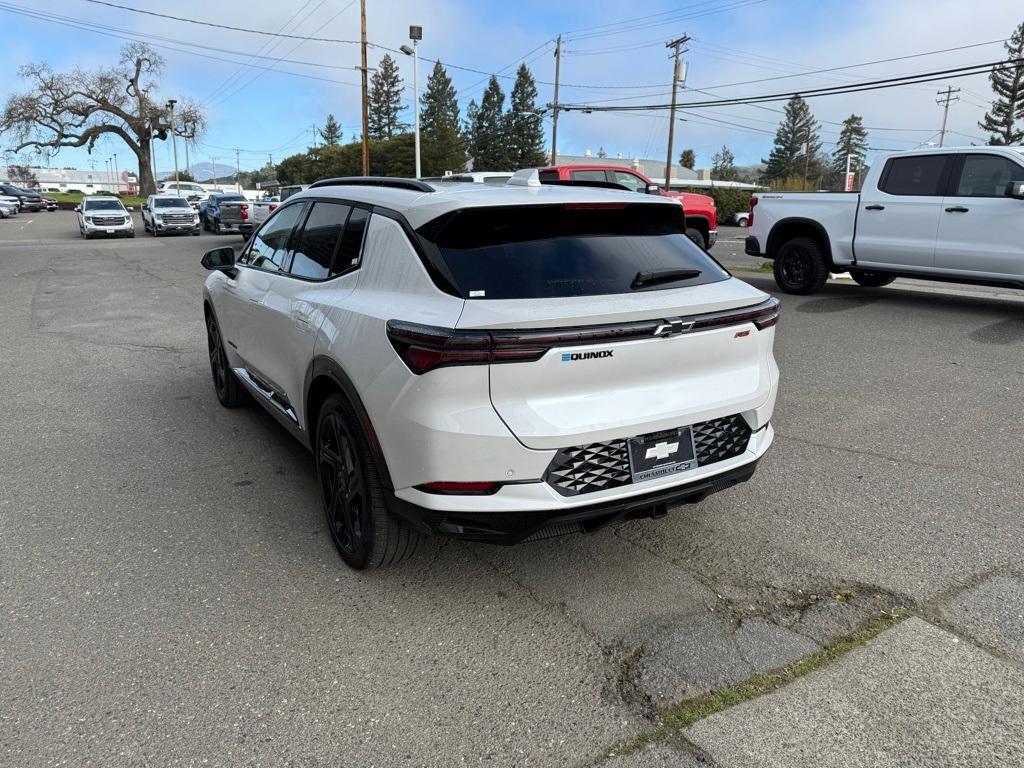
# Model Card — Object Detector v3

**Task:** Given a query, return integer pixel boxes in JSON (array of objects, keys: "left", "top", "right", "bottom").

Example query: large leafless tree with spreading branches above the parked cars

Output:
[{"left": 0, "top": 43, "right": 206, "bottom": 195}]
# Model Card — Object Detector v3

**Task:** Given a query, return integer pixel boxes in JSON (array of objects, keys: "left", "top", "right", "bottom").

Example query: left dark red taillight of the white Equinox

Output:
[{"left": 387, "top": 321, "right": 549, "bottom": 374}]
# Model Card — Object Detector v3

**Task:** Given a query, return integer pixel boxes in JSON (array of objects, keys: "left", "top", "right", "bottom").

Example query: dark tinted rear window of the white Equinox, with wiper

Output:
[{"left": 419, "top": 204, "right": 729, "bottom": 299}]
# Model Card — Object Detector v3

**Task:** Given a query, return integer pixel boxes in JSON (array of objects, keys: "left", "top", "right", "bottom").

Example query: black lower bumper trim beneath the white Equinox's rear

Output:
[{"left": 386, "top": 460, "right": 758, "bottom": 545}]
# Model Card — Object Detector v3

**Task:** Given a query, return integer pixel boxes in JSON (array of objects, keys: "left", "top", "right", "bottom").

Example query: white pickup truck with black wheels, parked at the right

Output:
[{"left": 744, "top": 146, "right": 1024, "bottom": 294}]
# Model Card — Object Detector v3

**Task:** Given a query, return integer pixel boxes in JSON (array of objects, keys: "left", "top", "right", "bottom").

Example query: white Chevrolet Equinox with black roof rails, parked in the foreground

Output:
[{"left": 197, "top": 176, "right": 778, "bottom": 568}]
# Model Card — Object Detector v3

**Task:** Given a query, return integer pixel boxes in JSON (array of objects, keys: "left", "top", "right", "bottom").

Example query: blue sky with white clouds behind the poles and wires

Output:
[{"left": 0, "top": 0, "right": 1024, "bottom": 176}]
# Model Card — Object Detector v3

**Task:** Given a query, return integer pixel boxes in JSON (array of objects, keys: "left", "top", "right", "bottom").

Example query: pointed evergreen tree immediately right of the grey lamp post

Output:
[{"left": 420, "top": 61, "right": 466, "bottom": 176}]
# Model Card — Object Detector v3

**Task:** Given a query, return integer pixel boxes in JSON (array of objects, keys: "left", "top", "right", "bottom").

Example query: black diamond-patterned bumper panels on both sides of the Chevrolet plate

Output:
[{"left": 544, "top": 414, "right": 751, "bottom": 496}]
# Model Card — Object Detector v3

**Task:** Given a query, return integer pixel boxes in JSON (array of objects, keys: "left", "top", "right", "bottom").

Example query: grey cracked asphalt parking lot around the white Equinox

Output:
[{"left": 0, "top": 212, "right": 1024, "bottom": 766}]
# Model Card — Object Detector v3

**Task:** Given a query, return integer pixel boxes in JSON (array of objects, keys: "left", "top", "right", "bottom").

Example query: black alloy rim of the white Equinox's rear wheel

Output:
[{"left": 316, "top": 413, "right": 371, "bottom": 567}]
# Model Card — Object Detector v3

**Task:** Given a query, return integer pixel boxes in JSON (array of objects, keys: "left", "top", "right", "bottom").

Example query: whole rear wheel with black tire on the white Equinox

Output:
[{"left": 314, "top": 394, "right": 421, "bottom": 570}]
